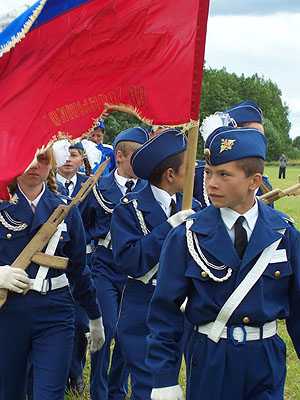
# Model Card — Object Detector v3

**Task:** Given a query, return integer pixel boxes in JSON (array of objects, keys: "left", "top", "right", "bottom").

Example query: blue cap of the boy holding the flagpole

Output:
[{"left": 130, "top": 128, "right": 187, "bottom": 180}]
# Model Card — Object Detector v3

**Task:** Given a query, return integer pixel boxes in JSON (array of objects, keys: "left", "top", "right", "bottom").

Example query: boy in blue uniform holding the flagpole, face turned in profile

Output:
[{"left": 111, "top": 129, "right": 200, "bottom": 400}]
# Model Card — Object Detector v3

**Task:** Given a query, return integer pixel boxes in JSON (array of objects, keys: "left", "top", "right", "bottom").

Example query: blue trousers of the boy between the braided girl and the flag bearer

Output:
[{"left": 90, "top": 269, "right": 128, "bottom": 400}]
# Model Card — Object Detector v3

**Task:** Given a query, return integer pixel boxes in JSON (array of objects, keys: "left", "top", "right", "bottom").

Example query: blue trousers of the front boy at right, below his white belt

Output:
[{"left": 186, "top": 331, "right": 286, "bottom": 400}]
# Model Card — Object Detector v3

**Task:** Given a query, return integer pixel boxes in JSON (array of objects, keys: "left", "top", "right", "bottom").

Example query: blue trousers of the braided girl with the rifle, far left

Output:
[{"left": 0, "top": 288, "right": 74, "bottom": 400}]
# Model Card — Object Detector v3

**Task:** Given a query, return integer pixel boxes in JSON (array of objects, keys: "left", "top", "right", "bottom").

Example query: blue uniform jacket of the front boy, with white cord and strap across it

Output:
[{"left": 148, "top": 201, "right": 300, "bottom": 387}]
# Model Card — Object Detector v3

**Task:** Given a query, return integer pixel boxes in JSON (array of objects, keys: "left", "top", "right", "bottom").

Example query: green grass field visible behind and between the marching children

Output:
[{"left": 65, "top": 166, "right": 300, "bottom": 400}]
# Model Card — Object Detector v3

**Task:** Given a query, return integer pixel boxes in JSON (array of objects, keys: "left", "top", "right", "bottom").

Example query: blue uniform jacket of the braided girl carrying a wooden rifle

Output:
[{"left": 0, "top": 188, "right": 101, "bottom": 319}]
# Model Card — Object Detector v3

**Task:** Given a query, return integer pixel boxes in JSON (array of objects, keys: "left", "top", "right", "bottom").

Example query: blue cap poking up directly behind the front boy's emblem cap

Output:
[{"left": 224, "top": 100, "right": 263, "bottom": 124}]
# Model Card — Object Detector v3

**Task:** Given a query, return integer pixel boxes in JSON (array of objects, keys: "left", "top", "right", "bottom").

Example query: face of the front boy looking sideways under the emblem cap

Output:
[{"left": 205, "top": 161, "right": 261, "bottom": 214}]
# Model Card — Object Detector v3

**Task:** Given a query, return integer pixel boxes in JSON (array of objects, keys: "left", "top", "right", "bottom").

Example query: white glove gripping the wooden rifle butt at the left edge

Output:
[{"left": 0, "top": 265, "right": 29, "bottom": 293}]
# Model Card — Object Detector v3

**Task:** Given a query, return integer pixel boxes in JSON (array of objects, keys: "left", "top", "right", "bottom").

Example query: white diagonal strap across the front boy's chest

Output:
[{"left": 207, "top": 229, "right": 285, "bottom": 343}]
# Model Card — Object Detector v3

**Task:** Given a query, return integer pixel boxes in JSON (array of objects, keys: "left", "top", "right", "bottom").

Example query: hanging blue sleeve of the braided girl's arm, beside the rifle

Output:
[{"left": 64, "top": 207, "right": 101, "bottom": 319}]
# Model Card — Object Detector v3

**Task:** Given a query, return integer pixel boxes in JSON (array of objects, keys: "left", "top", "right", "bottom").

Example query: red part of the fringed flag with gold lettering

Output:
[{"left": 0, "top": 0, "right": 209, "bottom": 199}]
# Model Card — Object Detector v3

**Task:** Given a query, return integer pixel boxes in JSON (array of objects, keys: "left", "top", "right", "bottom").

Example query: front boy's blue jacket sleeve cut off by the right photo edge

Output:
[{"left": 286, "top": 228, "right": 300, "bottom": 358}]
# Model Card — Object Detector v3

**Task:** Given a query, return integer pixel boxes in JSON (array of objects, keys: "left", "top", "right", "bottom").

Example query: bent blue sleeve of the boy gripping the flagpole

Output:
[{"left": 110, "top": 203, "right": 171, "bottom": 278}]
